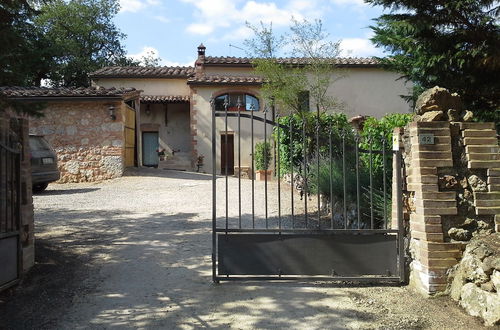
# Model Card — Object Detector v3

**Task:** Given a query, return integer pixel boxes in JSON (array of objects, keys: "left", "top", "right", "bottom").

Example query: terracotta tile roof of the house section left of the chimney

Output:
[{"left": 89, "top": 66, "right": 194, "bottom": 78}]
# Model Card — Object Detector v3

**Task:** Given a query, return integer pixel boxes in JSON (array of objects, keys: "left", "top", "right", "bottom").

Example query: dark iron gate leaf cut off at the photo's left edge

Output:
[{"left": 0, "top": 129, "right": 22, "bottom": 291}]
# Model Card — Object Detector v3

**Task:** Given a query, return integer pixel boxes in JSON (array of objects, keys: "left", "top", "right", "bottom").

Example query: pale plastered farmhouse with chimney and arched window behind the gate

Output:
[{"left": 90, "top": 44, "right": 411, "bottom": 174}]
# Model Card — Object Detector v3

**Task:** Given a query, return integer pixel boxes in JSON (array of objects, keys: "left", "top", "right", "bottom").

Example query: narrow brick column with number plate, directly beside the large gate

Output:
[{"left": 407, "top": 122, "right": 461, "bottom": 294}]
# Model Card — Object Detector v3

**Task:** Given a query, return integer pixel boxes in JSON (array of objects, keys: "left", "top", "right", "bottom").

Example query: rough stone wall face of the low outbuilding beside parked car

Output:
[{"left": 30, "top": 101, "right": 126, "bottom": 183}]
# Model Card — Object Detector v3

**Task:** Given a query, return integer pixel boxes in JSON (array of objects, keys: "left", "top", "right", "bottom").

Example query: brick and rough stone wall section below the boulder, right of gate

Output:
[{"left": 396, "top": 121, "right": 500, "bottom": 294}]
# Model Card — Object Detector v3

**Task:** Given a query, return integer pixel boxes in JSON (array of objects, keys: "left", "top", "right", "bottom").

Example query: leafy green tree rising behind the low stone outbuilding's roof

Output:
[{"left": 34, "top": 0, "right": 128, "bottom": 86}]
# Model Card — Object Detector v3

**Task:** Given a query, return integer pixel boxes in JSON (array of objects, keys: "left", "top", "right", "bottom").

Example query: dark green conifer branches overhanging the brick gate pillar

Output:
[{"left": 365, "top": 0, "right": 500, "bottom": 122}]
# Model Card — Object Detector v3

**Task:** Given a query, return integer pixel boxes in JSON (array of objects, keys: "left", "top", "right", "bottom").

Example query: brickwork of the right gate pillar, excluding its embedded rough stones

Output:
[{"left": 406, "top": 122, "right": 500, "bottom": 294}]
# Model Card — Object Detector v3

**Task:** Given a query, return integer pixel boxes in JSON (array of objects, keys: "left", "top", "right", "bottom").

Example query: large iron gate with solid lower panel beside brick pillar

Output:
[{"left": 212, "top": 102, "right": 404, "bottom": 282}]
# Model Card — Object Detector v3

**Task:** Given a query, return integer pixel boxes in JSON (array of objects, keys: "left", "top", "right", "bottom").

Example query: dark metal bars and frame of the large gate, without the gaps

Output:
[{"left": 211, "top": 99, "right": 405, "bottom": 282}]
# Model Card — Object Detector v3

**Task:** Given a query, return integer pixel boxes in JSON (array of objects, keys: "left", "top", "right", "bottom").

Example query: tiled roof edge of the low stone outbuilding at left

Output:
[{"left": 0, "top": 86, "right": 140, "bottom": 98}]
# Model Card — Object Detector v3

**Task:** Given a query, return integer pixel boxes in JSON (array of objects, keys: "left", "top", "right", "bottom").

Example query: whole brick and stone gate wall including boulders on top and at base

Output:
[{"left": 395, "top": 87, "right": 500, "bottom": 324}]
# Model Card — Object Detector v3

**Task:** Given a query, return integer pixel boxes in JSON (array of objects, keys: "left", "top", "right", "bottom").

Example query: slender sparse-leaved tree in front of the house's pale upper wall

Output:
[{"left": 244, "top": 18, "right": 339, "bottom": 113}]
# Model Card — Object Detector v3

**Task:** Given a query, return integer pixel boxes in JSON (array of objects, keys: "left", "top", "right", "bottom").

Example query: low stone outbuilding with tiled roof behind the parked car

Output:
[{"left": 0, "top": 87, "right": 140, "bottom": 182}]
